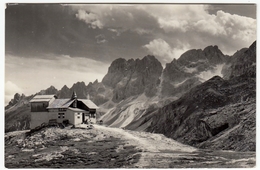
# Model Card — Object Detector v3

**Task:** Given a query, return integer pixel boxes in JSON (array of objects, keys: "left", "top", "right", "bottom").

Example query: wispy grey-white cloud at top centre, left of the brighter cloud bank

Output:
[{"left": 72, "top": 4, "right": 158, "bottom": 33}]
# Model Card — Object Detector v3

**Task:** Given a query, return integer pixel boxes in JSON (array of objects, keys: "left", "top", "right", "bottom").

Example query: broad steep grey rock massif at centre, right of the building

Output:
[{"left": 102, "top": 56, "right": 163, "bottom": 102}]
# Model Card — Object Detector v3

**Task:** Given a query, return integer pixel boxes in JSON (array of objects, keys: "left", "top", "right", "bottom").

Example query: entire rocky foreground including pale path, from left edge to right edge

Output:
[{"left": 5, "top": 125, "right": 255, "bottom": 168}]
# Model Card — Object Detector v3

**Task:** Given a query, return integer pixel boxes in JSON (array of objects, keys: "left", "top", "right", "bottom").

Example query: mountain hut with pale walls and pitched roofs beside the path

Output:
[{"left": 30, "top": 92, "right": 98, "bottom": 129}]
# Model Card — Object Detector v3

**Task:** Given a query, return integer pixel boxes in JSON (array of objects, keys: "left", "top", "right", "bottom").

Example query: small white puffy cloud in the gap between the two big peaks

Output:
[{"left": 143, "top": 39, "right": 188, "bottom": 64}]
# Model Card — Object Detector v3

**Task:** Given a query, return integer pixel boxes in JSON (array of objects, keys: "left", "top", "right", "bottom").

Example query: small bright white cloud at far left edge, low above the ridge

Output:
[{"left": 5, "top": 81, "right": 23, "bottom": 105}]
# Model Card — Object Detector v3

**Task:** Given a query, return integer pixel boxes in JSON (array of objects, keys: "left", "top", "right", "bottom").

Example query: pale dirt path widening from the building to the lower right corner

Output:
[{"left": 95, "top": 125, "right": 256, "bottom": 168}]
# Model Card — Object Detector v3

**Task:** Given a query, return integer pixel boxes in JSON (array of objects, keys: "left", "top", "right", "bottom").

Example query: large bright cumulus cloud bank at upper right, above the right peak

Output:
[{"left": 145, "top": 5, "right": 256, "bottom": 41}]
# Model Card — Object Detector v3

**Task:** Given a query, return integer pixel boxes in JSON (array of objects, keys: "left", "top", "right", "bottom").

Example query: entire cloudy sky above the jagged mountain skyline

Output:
[{"left": 4, "top": 4, "right": 256, "bottom": 104}]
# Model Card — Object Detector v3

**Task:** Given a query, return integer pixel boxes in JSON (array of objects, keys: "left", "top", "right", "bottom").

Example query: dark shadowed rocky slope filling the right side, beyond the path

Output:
[{"left": 147, "top": 40, "right": 256, "bottom": 151}]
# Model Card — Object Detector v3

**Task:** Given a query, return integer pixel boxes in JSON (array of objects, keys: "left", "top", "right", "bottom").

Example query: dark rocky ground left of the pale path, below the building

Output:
[{"left": 5, "top": 128, "right": 140, "bottom": 168}]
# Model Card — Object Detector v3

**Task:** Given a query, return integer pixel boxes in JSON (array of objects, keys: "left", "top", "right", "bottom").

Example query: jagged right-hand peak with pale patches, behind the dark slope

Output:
[{"left": 162, "top": 46, "right": 228, "bottom": 95}]
